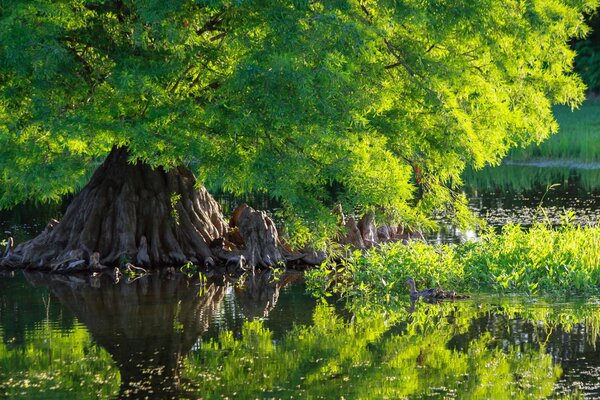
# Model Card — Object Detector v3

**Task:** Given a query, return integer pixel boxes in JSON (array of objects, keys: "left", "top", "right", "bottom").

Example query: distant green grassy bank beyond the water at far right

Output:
[{"left": 509, "top": 97, "right": 600, "bottom": 163}]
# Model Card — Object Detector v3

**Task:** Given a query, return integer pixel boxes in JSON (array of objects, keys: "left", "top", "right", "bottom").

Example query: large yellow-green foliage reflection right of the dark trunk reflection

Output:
[{"left": 184, "top": 305, "right": 560, "bottom": 398}]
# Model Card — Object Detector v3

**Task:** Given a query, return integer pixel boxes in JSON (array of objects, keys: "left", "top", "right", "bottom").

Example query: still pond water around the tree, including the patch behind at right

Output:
[{"left": 0, "top": 166, "right": 600, "bottom": 399}]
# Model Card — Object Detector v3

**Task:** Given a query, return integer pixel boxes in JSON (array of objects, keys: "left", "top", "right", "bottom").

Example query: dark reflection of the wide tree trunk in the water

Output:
[{"left": 28, "top": 274, "right": 225, "bottom": 398}]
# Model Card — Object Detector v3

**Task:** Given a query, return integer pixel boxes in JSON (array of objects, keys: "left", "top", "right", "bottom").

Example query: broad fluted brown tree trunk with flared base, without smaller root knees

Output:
[{"left": 2, "top": 148, "right": 227, "bottom": 271}]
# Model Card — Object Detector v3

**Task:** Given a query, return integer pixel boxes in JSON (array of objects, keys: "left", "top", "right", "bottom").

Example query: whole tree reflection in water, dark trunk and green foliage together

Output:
[{"left": 5, "top": 274, "right": 600, "bottom": 398}]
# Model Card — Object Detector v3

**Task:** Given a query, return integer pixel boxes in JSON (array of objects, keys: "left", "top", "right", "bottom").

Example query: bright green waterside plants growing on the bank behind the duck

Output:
[{"left": 307, "top": 224, "right": 600, "bottom": 305}]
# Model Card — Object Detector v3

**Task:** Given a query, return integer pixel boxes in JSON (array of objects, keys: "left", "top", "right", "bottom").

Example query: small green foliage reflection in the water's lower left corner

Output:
[{"left": 0, "top": 322, "right": 119, "bottom": 399}]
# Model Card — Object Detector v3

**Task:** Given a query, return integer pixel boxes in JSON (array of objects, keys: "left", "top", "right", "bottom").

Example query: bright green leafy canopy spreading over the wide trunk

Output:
[{"left": 0, "top": 0, "right": 598, "bottom": 241}]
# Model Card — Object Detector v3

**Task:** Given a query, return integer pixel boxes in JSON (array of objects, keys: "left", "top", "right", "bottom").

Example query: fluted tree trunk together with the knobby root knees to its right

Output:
[{"left": 0, "top": 147, "right": 422, "bottom": 273}]
